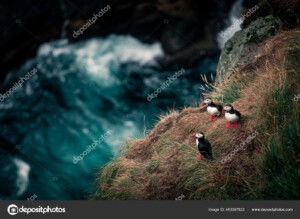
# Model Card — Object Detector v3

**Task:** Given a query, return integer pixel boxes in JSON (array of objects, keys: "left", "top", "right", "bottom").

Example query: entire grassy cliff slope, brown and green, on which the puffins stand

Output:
[{"left": 92, "top": 19, "right": 300, "bottom": 200}]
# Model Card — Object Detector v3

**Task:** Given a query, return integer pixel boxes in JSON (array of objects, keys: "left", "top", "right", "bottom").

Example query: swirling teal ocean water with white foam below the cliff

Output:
[{"left": 0, "top": 35, "right": 217, "bottom": 200}]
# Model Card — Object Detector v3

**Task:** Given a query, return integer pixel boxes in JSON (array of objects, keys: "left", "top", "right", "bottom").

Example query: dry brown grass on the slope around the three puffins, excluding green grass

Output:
[{"left": 95, "top": 31, "right": 300, "bottom": 199}]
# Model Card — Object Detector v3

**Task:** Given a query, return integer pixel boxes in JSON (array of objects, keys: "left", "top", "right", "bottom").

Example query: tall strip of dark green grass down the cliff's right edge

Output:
[{"left": 261, "top": 37, "right": 300, "bottom": 200}]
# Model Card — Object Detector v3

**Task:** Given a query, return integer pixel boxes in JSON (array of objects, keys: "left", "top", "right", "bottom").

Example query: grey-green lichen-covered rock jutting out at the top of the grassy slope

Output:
[{"left": 217, "top": 15, "right": 282, "bottom": 80}]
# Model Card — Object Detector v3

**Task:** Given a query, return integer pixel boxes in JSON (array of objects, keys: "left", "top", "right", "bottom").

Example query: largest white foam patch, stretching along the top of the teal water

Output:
[{"left": 38, "top": 35, "right": 164, "bottom": 87}]
